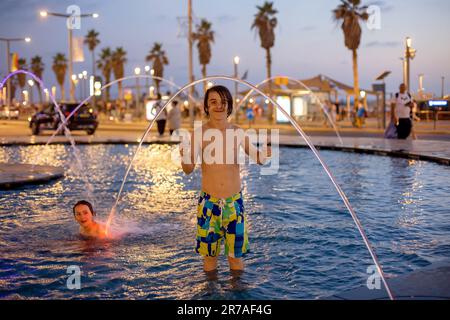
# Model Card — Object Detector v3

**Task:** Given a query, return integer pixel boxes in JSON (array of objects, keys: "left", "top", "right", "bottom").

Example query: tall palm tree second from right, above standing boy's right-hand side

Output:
[{"left": 251, "top": 1, "right": 278, "bottom": 121}]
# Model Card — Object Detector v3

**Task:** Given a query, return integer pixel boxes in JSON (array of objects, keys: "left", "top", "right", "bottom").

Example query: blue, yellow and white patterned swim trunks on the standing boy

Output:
[{"left": 195, "top": 191, "right": 249, "bottom": 258}]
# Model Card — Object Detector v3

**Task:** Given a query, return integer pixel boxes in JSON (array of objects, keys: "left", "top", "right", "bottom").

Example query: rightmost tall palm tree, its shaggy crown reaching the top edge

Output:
[{"left": 333, "top": 0, "right": 369, "bottom": 108}]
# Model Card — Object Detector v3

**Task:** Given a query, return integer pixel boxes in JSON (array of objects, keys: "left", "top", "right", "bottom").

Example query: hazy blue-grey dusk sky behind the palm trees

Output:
[{"left": 0, "top": 0, "right": 450, "bottom": 95}]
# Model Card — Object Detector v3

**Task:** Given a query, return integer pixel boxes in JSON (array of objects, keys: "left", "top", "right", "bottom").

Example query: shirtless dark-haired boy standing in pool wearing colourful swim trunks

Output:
[{"left": 180, "top": 86, "right": 272, "bottom": 272}]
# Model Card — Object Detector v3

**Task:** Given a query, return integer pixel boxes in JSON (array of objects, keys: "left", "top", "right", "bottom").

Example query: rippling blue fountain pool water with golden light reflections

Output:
[{"left": 0, "top": 145, "right": 450, "bottom": 299}]
